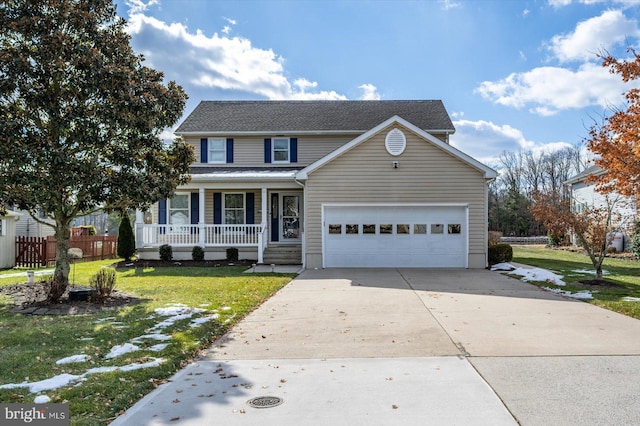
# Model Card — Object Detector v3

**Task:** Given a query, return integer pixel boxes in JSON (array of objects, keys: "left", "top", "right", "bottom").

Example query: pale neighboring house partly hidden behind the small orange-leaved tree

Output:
[{"left": 566, "top": 166, "right": 637, "bottom": 248}]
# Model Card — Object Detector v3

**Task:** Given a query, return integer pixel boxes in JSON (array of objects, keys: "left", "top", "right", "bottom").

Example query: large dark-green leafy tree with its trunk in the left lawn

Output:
[{"left": 0, "top": 0, "right": 193, "bottom": 302}]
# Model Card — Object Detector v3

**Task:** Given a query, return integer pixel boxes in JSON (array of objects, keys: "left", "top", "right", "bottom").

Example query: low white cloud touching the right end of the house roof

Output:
[{"left": 450, "top": 120, "right": 570, "bottom": 165}]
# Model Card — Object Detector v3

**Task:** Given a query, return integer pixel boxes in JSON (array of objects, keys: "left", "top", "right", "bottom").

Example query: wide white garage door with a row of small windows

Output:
[{"left": 323, "top": 205, "right": 469, "bottom": 268}]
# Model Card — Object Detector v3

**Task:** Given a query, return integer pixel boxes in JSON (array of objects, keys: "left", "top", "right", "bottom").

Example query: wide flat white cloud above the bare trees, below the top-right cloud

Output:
[{"left": 475, "top": 63, "right": 628, "bottom": 116}]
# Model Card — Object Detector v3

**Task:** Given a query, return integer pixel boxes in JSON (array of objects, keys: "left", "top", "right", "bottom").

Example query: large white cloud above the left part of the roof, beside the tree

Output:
[{"left": 128, "top": 13, "right": 346, "bottom": 99}]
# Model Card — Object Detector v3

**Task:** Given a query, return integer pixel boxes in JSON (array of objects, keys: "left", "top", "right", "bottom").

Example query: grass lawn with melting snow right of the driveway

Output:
[{"left": 513, "top": 246, "right": 640, "bottom": 319}]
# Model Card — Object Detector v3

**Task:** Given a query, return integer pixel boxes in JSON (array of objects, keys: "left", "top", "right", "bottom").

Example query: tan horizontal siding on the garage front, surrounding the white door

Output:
[{"left": 305, "top": 125, "right": 486, "bottom": 266}]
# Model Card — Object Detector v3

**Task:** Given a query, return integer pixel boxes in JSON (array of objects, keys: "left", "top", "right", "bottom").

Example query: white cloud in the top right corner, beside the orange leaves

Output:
[{"left": 549, "top": 10, "right": 640, "bottom": 62}]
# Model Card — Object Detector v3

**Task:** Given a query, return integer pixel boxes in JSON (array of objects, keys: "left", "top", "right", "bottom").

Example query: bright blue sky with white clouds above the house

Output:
[{"left": 116, "top": 0, "right": 640, "bottom": 164}]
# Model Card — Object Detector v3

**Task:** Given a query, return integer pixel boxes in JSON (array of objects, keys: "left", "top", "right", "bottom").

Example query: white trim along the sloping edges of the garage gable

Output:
[{"left": 296, "top": 116, "right": 498, "bottom": 180}]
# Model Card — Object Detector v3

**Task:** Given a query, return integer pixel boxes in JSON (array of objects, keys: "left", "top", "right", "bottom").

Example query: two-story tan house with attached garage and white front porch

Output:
[{"left": 136, "top": 100, "right": 496, "bottom": 268}]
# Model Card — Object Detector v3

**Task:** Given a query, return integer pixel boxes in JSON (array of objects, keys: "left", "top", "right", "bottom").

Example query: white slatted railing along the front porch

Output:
[{"left": 138, "top": 224, "right": 266, "bottom": 247}]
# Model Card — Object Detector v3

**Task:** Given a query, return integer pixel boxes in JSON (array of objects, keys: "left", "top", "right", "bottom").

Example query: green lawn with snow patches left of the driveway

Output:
[{"left": 0, "top": 260, "right": 294, "bottom": 425}]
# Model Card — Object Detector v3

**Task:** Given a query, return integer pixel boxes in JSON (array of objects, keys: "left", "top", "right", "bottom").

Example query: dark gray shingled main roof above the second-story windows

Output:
[{"left": 175, "top": 100, "right": 455, "bottom": 134}]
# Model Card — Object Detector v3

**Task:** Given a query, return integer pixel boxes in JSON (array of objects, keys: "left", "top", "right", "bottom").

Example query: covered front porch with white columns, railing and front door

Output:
[{"left": 135, "top": 185, "right": 303, "bottom": 265}]
